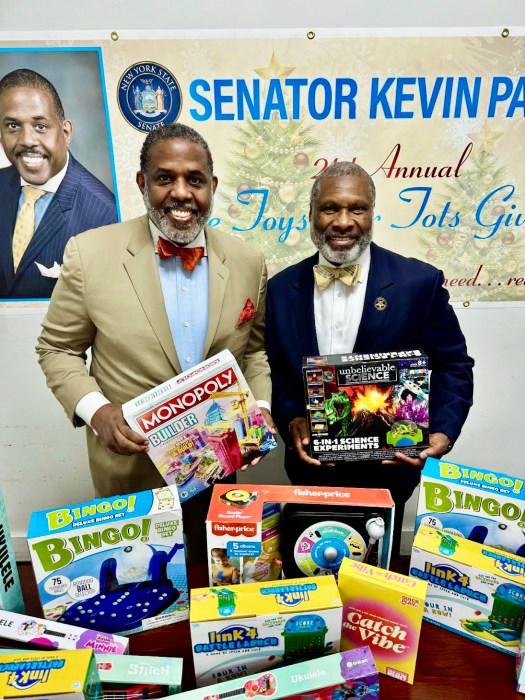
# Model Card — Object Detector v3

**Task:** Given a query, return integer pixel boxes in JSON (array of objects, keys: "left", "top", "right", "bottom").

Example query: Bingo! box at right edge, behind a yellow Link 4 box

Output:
[{"left": 416, "top": 457, "right": 525, "bottom": 557}]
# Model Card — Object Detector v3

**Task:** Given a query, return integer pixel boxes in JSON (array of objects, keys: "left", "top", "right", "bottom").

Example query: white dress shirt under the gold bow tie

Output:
[{"left": 314, "top": 246, "right": 370, "bottom": 355}]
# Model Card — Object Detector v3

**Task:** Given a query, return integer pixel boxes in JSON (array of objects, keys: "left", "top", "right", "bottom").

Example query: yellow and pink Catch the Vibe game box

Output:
[{"left": 338, "top": 559, "right": 427, "bottom": 683}]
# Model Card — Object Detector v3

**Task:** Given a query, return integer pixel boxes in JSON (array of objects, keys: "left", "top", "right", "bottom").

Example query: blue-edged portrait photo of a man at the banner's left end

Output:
[{"left": 0, "top": 49, "right": 119, "bottom": 301}]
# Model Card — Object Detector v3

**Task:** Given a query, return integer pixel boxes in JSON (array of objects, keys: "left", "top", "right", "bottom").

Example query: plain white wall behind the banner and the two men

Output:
[{"left": 0, "top": 0, "right": 525, "bottom": 556}]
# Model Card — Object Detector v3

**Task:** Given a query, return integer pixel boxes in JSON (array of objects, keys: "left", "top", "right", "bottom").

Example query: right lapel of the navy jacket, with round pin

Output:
[{"left": 354, "top": 243, "right": 395, "bottom": 352}]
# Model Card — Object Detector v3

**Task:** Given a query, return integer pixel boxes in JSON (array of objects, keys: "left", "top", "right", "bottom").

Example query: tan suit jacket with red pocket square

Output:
[{"left": 37, "top": 216, "right": 271, "bottom": 496}]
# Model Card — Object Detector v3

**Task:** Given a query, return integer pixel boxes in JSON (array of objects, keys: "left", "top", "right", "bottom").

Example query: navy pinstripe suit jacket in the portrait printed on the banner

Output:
[{"left": 0, "top": 154, "right": 118, "bottom": 299}]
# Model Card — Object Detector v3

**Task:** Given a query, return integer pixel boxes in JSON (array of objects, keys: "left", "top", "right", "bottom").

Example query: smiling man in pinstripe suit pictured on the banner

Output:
[{"left": 0, "top": 68, "right": 117, "bottom": 299}]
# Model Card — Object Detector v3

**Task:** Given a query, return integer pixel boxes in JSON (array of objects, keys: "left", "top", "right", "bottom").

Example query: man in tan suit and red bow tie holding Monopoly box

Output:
[{"left": 37, "top": 124, "right": 273, "bottom": 540}]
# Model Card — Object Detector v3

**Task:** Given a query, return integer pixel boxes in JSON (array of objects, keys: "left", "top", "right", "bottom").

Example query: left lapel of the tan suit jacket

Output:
[{"left": 124, "top": 216, "right": 182, "bottom": 374}]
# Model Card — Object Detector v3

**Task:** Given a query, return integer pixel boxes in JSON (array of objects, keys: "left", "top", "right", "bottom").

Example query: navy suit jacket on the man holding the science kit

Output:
[{"left": 266, "top": 243, "right": 474, "bottom": 456}]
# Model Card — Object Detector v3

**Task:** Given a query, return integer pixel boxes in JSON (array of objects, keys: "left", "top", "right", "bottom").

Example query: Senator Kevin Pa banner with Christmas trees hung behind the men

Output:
[{"left": 0, "top": 32, "right": 525, "bottom": 303}]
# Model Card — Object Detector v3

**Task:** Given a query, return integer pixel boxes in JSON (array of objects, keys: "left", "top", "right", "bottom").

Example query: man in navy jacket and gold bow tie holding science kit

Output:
[{"left": 266, "top": 163, "right": 474, "bottom": 554}]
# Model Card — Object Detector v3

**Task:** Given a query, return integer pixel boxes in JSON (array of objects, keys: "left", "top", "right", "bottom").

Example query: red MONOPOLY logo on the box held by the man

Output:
[{"left": 137, "top": 367, "right": 237, "bottom": 433}]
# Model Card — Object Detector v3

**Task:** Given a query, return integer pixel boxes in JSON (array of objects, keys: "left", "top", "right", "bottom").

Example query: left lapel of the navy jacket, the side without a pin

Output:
[{"left": 290, "top": 253, "right": 319, "bottom": 356}]
